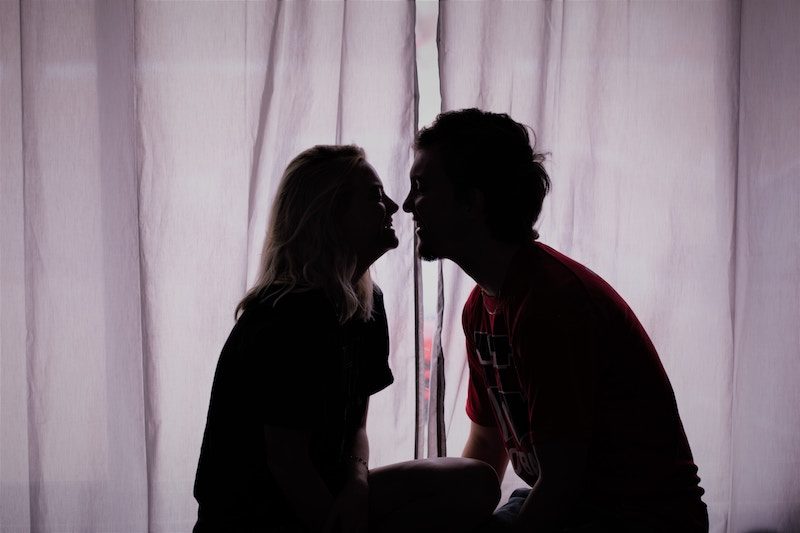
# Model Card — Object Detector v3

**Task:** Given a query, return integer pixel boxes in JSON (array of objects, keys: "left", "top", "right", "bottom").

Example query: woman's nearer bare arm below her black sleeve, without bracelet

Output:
[{"left": 264, "top": 426, "right": 333, "bottom": 531}]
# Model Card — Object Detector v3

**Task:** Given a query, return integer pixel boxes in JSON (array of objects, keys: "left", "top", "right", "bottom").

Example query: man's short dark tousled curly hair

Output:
[{"left": 414, "top": 109, "right": 550, "bottom": 242}]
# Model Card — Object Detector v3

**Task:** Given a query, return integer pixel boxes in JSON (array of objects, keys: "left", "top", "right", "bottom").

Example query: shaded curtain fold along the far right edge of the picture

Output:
[{"left": 730, "top": 1, "right": 800, "bottom": 531}]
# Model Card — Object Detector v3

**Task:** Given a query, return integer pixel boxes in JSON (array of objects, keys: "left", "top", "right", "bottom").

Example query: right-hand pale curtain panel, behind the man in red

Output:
[{"left": 430, "top": 0, "right": 800, "bottom": 532}]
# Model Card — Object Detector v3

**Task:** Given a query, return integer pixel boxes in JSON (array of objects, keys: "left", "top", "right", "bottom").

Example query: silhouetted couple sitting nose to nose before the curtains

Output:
[{"left": 194, "top": 109, "right": 708, "bottom": 533}]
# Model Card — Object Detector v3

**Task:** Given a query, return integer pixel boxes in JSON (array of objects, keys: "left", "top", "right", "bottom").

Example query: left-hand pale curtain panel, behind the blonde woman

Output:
[{"left": 0, "top": 0, "right": 415, "bottom": 532}]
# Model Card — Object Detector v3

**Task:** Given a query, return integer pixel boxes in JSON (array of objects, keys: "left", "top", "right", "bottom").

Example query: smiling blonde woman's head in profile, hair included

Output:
[{"left": 236, "top": 146, "right": 397, "bottom": 322}]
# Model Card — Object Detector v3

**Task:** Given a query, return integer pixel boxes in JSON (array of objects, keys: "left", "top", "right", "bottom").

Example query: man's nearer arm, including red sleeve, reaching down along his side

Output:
[{"left": 513, "top": 297, "right": 599, "bottom": 533}]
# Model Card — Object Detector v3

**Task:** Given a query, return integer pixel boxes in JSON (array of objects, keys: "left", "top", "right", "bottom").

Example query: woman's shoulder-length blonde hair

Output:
[{"left": 235, "top": 145, "right": 373, "bottom": 323}]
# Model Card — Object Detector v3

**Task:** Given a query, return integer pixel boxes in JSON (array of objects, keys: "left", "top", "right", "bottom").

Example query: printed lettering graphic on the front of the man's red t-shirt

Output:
[{"left": 474, "top": 331, "right": 539, "bottom": 480}]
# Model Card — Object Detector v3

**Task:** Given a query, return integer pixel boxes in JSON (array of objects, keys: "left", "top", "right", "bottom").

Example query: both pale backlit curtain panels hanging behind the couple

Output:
[{"left": 0, "top": 0, "right": 800, "bottom": 533}]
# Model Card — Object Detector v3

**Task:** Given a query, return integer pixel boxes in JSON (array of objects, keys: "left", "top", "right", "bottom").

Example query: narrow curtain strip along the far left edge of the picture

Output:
[{"left": 0, "top": 2, "right": 30, "bottom": 531}]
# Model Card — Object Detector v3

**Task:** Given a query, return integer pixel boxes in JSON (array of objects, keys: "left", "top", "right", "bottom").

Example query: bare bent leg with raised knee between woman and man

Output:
[{"left": 369, "top": 457, "right": 500, "bottom": 533}]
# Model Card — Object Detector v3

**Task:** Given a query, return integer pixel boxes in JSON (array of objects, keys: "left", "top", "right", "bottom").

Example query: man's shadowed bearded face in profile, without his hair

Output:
[{"left": 403, "top": 148, "right": 464, "bottom": 261}]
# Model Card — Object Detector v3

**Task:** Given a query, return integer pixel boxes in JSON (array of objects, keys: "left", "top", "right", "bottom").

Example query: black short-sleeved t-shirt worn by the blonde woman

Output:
[{"left": 194, "top": 288, "right": 393, "bottom": 531}]
